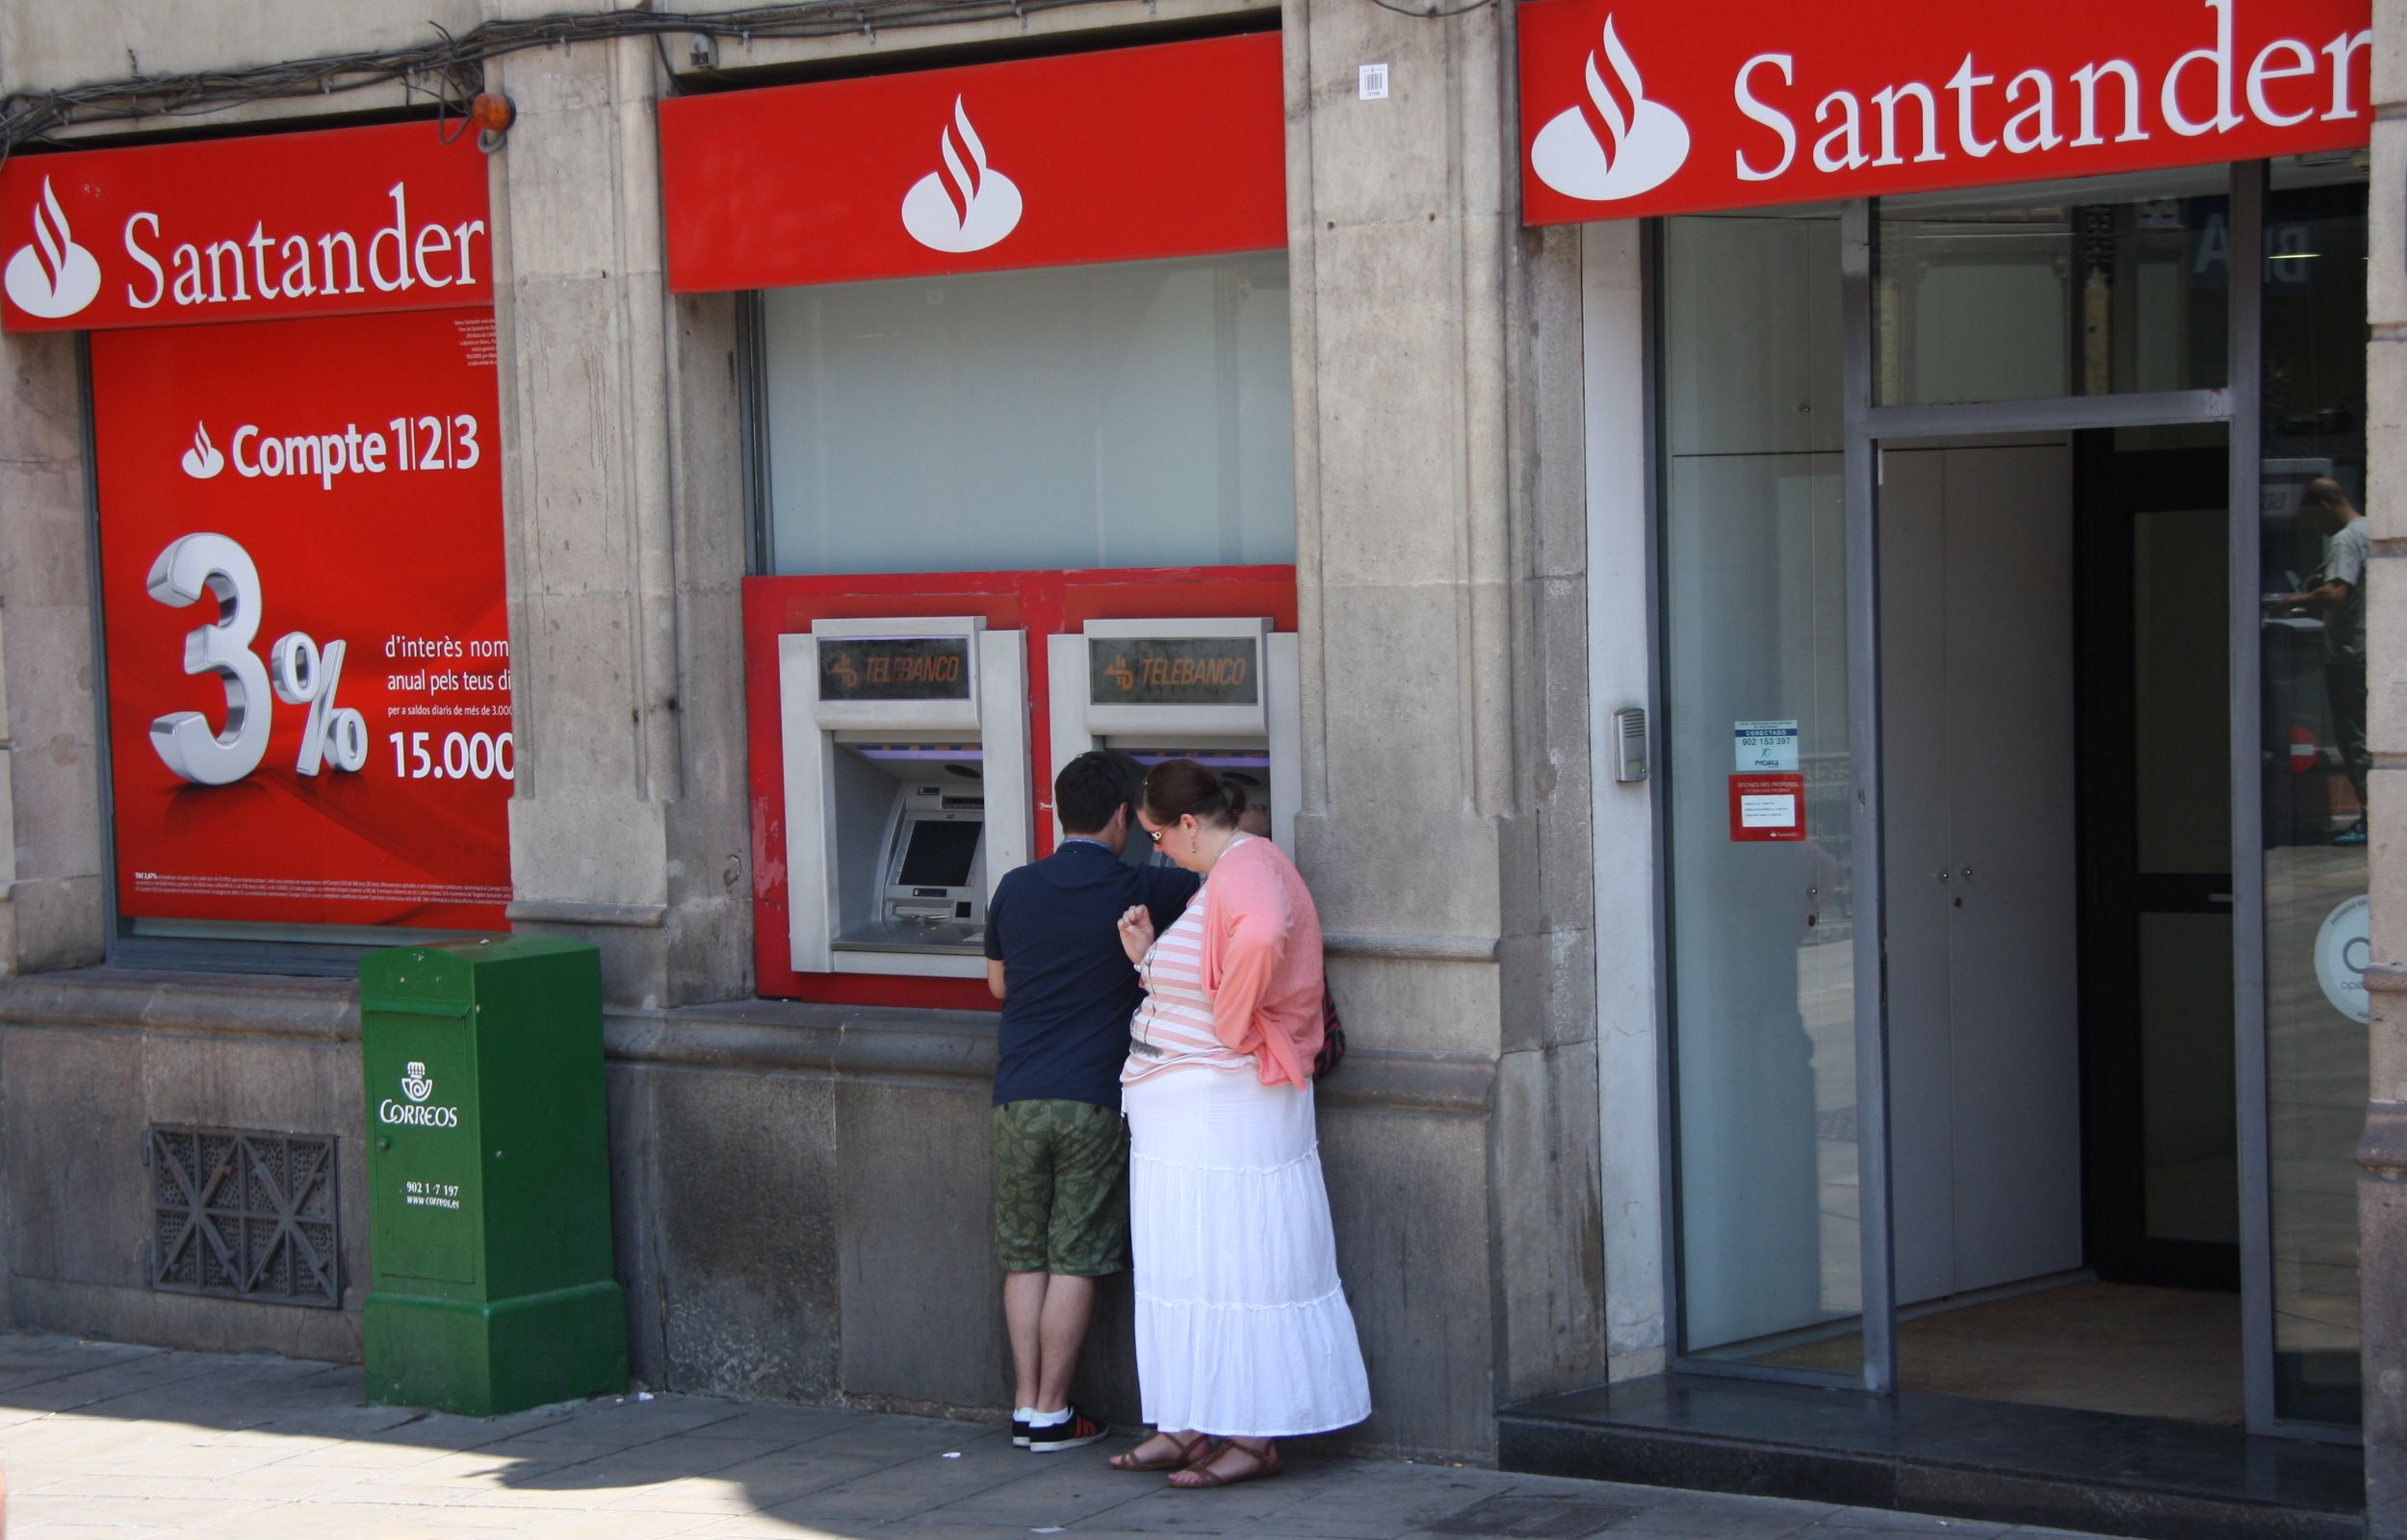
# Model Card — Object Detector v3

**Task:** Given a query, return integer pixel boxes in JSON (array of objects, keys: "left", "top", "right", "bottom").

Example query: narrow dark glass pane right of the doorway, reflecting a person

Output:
[{"left": 2261, "top": 164, "right": 2367, "bottom": 1423}]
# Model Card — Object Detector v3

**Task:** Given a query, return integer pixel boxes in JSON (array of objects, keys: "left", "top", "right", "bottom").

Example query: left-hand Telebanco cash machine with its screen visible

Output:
[{"left": 778, "top": 616, "right": 1033, "bottom": 980}]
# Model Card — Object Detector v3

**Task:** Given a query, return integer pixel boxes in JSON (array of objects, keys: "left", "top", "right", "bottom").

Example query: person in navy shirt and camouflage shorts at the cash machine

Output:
[{"left": 987, "top": 749, "right": 1202, "bottom": 1451}]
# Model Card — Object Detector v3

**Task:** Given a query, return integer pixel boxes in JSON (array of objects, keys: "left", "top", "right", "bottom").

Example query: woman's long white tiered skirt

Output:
[{"left": 1122, "top": 1068, "right": 1370, "bottom": 1439}]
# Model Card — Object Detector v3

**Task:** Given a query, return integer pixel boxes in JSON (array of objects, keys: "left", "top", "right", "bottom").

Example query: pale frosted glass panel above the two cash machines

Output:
[{"left": 764, "top": 253, "right": 1295, "bottom": 573}]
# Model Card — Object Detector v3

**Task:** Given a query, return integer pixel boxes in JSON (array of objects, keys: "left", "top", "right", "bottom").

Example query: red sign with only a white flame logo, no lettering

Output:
[{"left": 660, "top": 32, "right": 1288, "bottom": 294}]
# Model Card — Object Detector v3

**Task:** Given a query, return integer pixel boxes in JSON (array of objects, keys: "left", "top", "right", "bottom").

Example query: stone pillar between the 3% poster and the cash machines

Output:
[{"left": 491, "top": 38, "right": 749, "bottom": 1006}]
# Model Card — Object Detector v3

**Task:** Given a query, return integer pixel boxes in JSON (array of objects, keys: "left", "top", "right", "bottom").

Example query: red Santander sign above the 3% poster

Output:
[{"left": 0, "top": 123, "right": 494, "bottom": 332}]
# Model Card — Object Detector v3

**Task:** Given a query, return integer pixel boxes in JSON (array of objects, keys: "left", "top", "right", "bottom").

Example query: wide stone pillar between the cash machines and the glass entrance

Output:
[{"left": 1285, "top": 0, "right": 1603, "bottom": 1449}]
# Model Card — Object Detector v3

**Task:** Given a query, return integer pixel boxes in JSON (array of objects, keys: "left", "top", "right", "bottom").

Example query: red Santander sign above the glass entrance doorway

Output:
[{"left": 1519, "top": 0, "right": 2373, "bottom": 224}]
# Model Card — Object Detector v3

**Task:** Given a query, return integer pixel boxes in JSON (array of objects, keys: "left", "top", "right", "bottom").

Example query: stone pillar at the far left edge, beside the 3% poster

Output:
[{"left": 0, "top": 332, "right": 104, "bottom": 975}]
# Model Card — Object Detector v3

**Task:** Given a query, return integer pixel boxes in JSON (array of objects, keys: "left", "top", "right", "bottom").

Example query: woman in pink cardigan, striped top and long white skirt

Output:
[{"left": 1112, "top": 760, "right": 1370, "bottom": 1487}]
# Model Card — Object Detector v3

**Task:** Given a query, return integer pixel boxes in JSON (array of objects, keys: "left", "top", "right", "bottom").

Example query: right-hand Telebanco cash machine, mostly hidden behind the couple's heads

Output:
[{"left": 1048, "top": 616, "right": 1305, "bottom": 857}]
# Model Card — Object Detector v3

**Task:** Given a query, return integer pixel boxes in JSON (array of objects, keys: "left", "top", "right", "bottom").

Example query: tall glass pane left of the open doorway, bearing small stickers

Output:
[{"left": 1664, "top": 217, "right": 1863, "bottom": 1370}]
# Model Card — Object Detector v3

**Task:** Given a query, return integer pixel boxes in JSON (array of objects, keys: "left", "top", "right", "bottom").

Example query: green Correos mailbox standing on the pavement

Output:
[{"left": 359, "top": 937, "right": 626, "bottom": 1418}]
